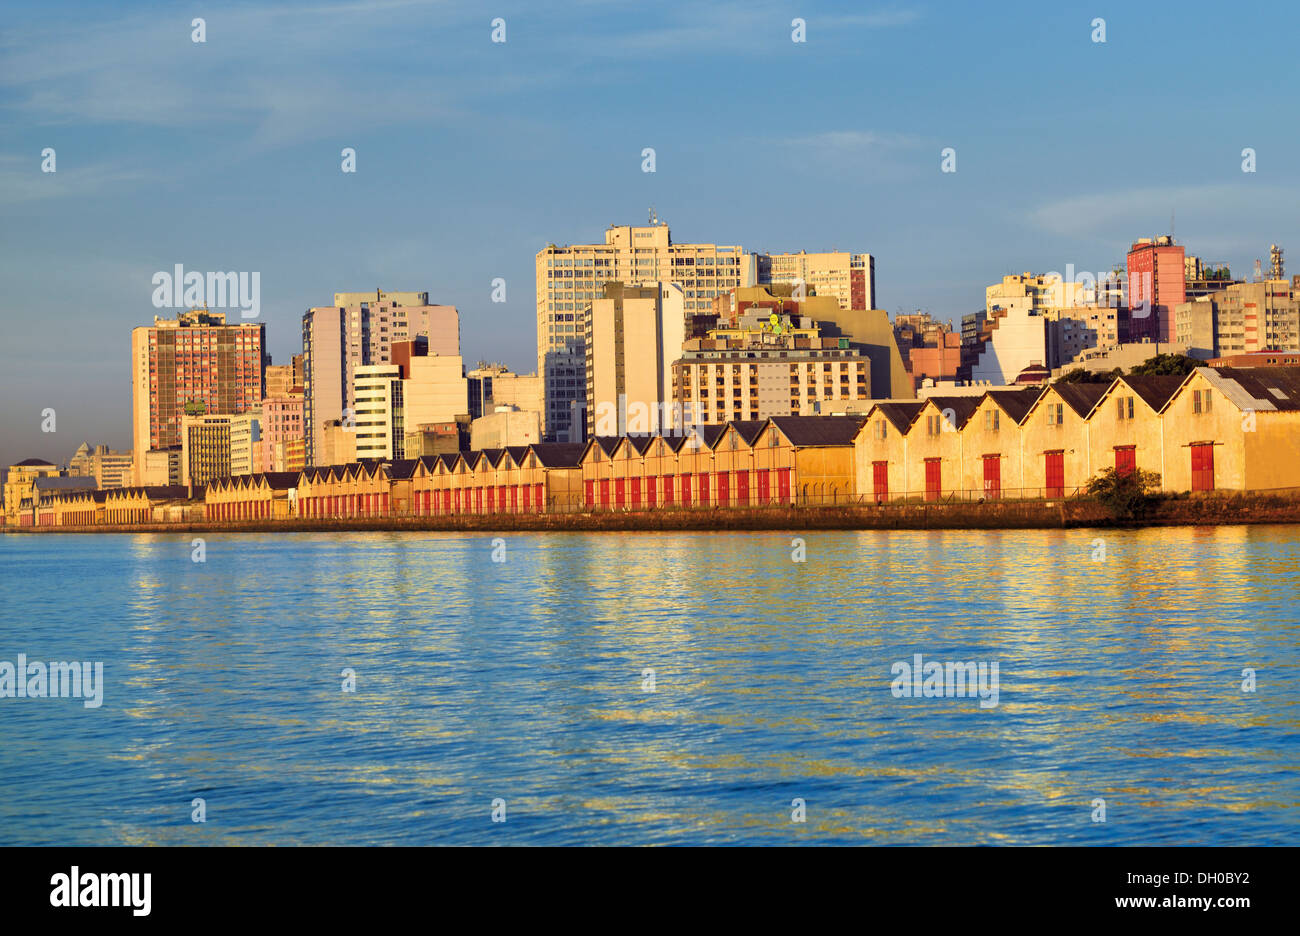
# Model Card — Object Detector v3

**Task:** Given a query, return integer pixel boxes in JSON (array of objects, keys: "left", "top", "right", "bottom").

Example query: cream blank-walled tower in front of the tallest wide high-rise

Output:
[{"left": 582, "top": 282, "right": 686, "bottom": 438}]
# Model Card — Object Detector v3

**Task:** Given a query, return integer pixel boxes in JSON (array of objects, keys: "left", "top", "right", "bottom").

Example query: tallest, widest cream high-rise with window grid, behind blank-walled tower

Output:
[{"left": 537, "top": 217, "right": 757, "bottom": 442}]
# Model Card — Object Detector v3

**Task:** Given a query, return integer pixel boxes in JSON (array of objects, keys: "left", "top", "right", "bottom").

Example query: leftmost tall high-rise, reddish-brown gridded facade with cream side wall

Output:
[{"left": 131, "top": 309, "right": 268, "bottom": 484}]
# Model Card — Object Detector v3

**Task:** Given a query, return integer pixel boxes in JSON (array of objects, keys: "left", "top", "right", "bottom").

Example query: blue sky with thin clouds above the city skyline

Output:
[{"left": 0, "top": 0, "right": 1300, "bottom": 464}]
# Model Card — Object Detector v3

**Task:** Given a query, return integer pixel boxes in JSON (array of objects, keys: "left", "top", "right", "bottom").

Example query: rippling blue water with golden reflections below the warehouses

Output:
[{"left": 0, "top": 527, "right": 1300, "bottom": 845}]
